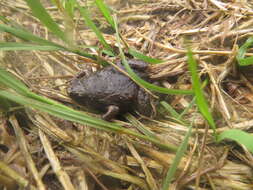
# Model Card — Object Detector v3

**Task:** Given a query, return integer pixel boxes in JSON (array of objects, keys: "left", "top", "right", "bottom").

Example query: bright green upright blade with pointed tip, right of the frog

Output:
[{"left": 187, "top": 49, "right": 217, "bottom": 137}]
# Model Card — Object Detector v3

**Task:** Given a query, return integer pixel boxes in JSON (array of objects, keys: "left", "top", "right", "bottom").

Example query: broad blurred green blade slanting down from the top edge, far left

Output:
[{"left": 25, "top": 0, "right": 68, "bottom": 42}]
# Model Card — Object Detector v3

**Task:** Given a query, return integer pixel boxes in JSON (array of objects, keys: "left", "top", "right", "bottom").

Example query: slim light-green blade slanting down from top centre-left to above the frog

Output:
[{"left": 77, "top": 3, "right": 114, "bottom": 56}]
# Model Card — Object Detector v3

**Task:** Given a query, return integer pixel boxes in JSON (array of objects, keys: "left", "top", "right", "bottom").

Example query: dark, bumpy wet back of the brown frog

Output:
[{"left": 79, "top": 66, "right": 139, "bottom": 109}]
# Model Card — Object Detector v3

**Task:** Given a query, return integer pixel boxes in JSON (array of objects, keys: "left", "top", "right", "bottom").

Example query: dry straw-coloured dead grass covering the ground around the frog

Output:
[{"left": 0, "top": 0, "right": 253, "bottom": 190}]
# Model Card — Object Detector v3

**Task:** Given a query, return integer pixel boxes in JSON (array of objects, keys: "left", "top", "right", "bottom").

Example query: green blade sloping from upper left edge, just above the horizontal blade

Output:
[{"left": 0, "top": 24, "right": 63, "bottom": 48}]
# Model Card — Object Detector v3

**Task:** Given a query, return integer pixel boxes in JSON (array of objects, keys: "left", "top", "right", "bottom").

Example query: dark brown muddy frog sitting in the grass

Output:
[{"left": 67, "top": 59, "right": 155, "bottom": 121}]
